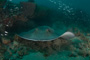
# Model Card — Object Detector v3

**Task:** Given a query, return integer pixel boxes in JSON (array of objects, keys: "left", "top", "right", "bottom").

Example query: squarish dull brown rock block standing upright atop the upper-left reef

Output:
[{"left": 21, "top": 2, "right": 36, "bottom": 18}]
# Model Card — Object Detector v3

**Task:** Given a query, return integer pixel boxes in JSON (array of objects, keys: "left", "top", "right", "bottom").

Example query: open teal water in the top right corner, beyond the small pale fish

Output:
[{"left": 57, "top": 0, "right": 90, "bottom": 13}]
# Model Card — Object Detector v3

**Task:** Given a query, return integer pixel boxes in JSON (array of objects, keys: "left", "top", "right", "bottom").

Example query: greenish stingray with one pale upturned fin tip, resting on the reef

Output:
[{"left": 18, "top": 26, "right": 74, "bottom": 41}]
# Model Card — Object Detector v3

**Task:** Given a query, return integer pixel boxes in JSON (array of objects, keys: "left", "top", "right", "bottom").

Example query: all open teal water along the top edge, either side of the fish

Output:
[{"left": 8, "top": 0, "right": 90, "bottom": 14}]
